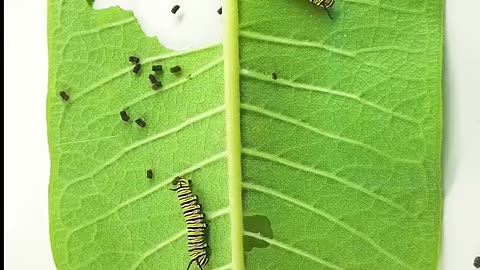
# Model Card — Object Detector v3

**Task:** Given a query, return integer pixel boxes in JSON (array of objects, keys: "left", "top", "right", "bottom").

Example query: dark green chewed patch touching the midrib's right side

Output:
[{"left": 243, "top": 215, "right": 273, "bottom": 252}]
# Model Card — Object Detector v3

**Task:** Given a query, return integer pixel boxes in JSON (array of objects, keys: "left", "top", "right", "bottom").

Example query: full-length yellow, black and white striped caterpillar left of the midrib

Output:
[{"left": 171, "top": 177, "right": 208, "bottom": 270}]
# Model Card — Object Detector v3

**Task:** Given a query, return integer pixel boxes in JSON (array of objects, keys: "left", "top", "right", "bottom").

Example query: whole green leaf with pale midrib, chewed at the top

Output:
[{"left": 47, "top": 0, "right": 443, "bottom": 270}]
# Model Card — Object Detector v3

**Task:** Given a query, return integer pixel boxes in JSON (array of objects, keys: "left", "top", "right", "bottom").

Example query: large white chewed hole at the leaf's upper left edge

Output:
[{"left": 90, "top": 0, "right": 223, "bottom": 50}]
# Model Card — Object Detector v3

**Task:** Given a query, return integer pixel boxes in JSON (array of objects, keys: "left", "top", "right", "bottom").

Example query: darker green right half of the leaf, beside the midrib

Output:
[{"left": 240, "top": 0, "right": 443, "bottom": 270}]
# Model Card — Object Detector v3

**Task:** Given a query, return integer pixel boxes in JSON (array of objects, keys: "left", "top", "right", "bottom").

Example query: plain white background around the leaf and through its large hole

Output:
[{"left": 4, "top": 0, "right": 480, "bottom": 270}]
